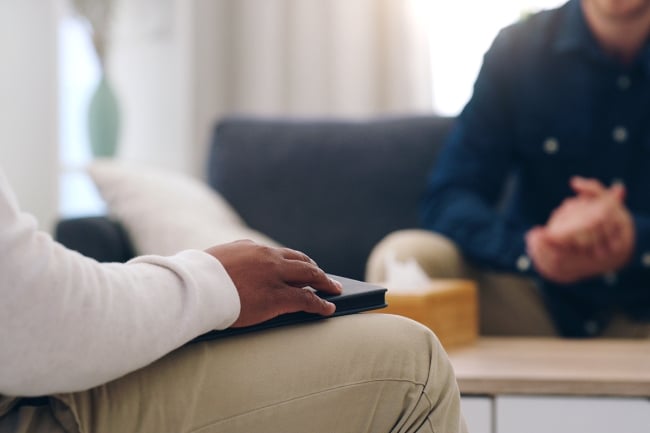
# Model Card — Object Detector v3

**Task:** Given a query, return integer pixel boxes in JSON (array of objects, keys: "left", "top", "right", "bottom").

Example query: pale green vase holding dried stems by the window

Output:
[{"left": 88, "top": 73, "right": 120, "bottom": 158}]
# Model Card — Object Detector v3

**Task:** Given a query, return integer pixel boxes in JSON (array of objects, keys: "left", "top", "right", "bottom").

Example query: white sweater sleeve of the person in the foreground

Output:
[{"left": 0, "top": 172, "right": 240, "bottom": 396}]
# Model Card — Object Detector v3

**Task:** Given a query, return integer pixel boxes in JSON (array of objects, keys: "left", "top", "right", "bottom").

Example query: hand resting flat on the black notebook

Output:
[{"left": 206, "top": 240, "right": 341, "bottom": 327}]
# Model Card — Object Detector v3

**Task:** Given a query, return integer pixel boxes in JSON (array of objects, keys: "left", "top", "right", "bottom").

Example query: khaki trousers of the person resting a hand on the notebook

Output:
[{"left": 0, "top": 314, "right": 466, "bottom": 433}]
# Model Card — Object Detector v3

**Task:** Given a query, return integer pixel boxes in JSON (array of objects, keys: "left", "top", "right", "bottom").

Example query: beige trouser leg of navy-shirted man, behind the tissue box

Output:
[{"left": 366, "top": 230, "right": 556, "bottom": 336}]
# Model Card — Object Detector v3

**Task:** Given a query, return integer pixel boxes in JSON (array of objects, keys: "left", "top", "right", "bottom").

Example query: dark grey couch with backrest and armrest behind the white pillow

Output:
[{"left": 55, "top": 116, "right": 453, "bottom": 279}]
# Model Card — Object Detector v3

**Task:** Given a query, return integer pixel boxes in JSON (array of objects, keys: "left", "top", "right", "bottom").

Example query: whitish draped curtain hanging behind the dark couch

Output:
[{"left": 187, "top": 0, "right": 432, "bottom": 174}]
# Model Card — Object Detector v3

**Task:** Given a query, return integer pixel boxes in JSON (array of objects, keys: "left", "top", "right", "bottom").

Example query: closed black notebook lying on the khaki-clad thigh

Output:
[{"left": 192, "top": 275, "right": 386, "bottom": 342}]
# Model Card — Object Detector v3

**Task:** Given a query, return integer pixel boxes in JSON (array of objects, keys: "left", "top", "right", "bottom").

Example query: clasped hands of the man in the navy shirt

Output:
[{"left": 526, "top": 177, "right": 634, "bottom": 284}]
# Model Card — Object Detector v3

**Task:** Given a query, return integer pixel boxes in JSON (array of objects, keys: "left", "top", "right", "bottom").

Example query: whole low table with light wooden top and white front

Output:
[{"left": 448, "top": 337, "right": 650, "bottom": 433}]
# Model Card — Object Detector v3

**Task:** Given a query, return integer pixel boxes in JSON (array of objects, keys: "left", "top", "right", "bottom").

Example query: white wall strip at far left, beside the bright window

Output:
[{"left": 0, "top": 0, "right": 58, "bottom": 230}]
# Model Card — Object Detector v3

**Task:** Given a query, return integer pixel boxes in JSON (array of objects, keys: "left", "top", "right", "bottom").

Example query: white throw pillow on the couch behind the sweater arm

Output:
[{"left": 88, "top": 159, "right": 278, "bottom": 255}]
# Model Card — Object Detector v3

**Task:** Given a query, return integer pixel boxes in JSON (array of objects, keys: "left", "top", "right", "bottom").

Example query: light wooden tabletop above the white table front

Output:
[{"left": 449, "top": 337, "right": 650, "bottom": 397}]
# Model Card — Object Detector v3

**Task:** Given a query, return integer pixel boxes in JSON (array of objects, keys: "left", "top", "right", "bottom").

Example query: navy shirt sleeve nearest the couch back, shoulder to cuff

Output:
[{"left": 422, "top": 27, "right": 532, "bottom": 273}]
